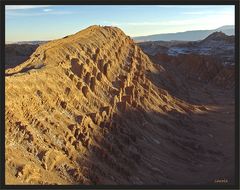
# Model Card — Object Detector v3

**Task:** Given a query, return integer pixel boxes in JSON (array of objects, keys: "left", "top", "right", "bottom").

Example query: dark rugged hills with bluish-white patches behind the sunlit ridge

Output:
[{"left": 138, "top": 32, "right": 235, "bottom": 65}]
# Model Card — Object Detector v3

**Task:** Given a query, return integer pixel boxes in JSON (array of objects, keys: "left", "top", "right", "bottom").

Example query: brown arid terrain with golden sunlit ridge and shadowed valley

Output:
[{"left": 5, "top": 26, "right": 235, "bottom": 185}]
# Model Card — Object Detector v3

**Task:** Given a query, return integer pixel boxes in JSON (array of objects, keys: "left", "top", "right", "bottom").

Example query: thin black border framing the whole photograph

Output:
[{"left": 0, "top": 0, "right": 240, "bottom": 189}]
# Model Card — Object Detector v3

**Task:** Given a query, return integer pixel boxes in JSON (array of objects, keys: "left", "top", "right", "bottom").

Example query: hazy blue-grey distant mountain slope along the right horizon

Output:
[{"left": 133, "top": 25, "right": 235, "bottom": 42}]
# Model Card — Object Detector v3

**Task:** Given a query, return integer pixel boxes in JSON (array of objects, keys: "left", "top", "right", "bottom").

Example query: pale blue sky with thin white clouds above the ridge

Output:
[{"left": 6, "top": 5, "right": 234, "bottom": 42}]
